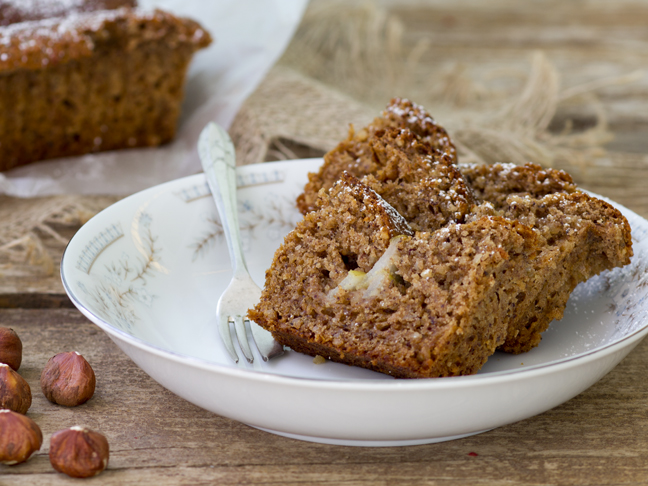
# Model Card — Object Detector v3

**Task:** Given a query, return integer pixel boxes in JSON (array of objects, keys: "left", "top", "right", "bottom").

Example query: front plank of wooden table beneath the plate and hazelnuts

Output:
[{"left": 0, "top": 309, "right": 648, "bottom": 486}]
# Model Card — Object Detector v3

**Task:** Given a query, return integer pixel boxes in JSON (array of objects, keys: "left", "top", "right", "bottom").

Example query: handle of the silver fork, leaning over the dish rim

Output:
[{"left": 198, "top": 122, "right": 248, "bottom": 276}]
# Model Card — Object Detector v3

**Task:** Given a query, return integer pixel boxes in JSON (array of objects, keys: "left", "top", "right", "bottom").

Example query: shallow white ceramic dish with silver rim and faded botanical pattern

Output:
[{"left": 61, "top": 159, "right": 648, "bottom": 446}]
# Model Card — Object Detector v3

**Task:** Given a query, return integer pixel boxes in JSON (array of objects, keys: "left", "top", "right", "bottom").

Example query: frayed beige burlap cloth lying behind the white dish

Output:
[{"left": 0, "top": 1, "right": 648, "bottom": 276}]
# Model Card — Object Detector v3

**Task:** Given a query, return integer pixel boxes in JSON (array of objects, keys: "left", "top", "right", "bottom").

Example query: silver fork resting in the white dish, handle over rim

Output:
[{"left": 198, "top": 123, "right": 283, "bottom": 363}]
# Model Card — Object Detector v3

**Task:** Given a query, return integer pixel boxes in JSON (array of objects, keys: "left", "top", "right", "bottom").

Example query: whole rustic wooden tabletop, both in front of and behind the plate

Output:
[{"left": 0, "top": 1, "right": 648, "bottom": 486}]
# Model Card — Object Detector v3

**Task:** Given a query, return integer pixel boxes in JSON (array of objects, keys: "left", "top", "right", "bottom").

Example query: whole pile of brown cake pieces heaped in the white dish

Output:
[{"left": 249, "top": 99, "right": 632, "bottom": 378}]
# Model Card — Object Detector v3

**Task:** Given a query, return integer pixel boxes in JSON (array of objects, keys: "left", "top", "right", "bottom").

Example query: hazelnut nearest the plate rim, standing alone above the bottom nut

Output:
[{"left": 41, "top": 351, "right": 96, "bottom": 407}]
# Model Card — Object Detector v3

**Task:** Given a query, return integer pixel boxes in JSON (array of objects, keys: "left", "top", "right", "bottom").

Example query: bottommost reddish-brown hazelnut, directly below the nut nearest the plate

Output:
[{"left": 50, "top": 427, "right": 109, "bottom": 478}]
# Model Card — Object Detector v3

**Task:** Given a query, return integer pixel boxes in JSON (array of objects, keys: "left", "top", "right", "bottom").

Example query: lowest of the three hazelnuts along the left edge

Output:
[{"left": 0, "top": 410, "right": 43, "bottom": 465}]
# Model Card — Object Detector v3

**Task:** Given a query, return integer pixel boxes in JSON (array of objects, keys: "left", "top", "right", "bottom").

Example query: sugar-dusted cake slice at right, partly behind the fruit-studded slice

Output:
[{"left": 461, "top": 164, "right": 632, "bottom": 353}]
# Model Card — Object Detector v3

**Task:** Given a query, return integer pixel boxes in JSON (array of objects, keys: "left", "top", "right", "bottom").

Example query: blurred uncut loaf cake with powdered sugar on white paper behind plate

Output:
[{"left": 0, "top": 0, "right": 211, "bottom": 170}]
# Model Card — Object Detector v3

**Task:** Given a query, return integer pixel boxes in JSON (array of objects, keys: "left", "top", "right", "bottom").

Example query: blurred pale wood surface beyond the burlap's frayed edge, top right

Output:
[{"left": 392, "top": 0, "right": 648, "bottom": 127}]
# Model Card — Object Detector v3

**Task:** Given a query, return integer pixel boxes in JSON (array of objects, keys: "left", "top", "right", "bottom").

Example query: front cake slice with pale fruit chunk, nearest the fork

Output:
[{"left": 248, "top": 174, "right": 539, "bottom": 378}]
